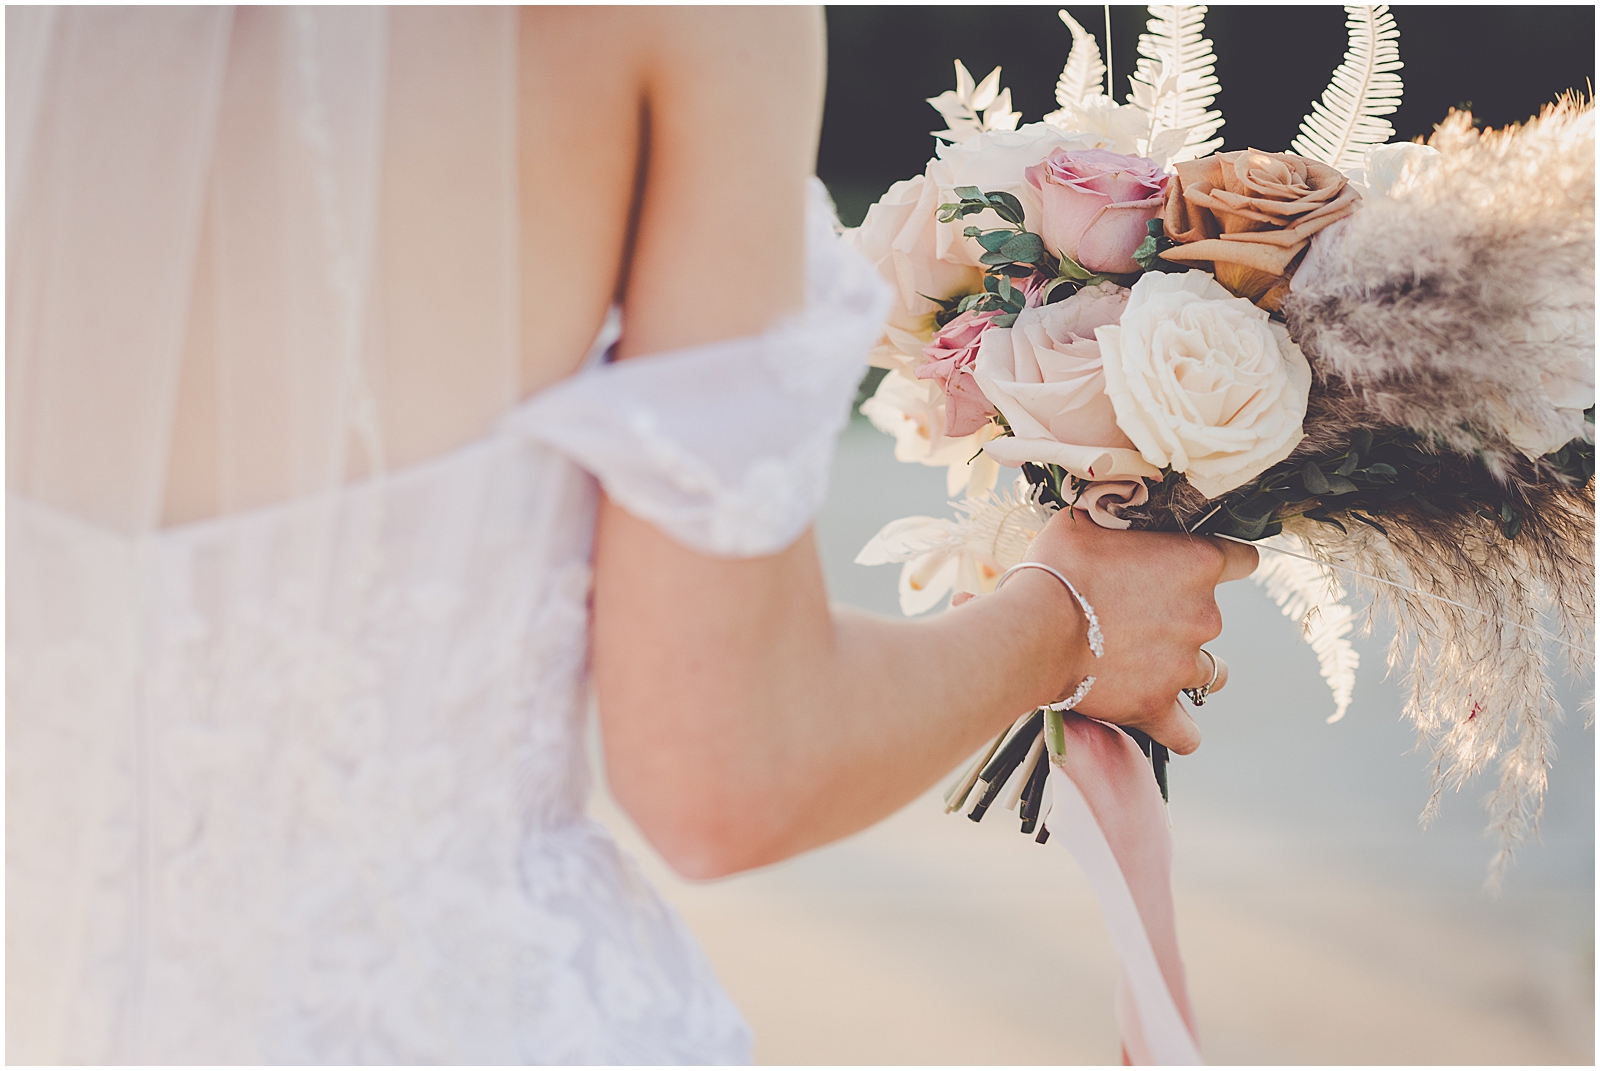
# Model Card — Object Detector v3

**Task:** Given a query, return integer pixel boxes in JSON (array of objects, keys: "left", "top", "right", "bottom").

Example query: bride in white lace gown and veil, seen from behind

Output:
[{"left": 6, "top": 8, "right": 1254, "bottom": 1063}]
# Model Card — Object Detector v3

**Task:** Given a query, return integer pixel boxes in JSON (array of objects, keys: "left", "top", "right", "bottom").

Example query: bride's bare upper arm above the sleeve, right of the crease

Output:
[{"left": 622, "top": 8, "right": 824, "bottom": 355}]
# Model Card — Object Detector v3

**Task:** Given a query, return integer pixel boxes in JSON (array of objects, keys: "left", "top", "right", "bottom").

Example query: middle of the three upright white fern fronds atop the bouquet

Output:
[{"left": 1128, "top": 3, "right": 1222, "bottom": 163}]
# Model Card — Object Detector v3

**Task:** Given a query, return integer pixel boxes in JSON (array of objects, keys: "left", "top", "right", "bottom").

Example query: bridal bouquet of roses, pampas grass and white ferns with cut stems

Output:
[{"left": 851, "top": 6, "right": 1595, "bottom": 869}]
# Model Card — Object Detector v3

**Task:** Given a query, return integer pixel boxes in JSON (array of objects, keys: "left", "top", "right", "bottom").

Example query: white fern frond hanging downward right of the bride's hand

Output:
[{"left": 1250, "top": 535, "right": 1362, "bottom": 725}]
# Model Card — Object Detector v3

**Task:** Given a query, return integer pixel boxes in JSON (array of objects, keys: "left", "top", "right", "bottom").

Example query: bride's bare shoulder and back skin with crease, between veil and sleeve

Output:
[{"left": 518, "top": 6, "right": 826, "bottom": 379}]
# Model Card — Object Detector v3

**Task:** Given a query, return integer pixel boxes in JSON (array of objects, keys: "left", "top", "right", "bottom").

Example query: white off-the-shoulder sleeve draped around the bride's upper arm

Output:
[{"left": 509, "top": 179, "right": 888, "bottom": 557}]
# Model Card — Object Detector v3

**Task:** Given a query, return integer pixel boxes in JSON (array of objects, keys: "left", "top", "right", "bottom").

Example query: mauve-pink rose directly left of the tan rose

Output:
[{"left": 1027, "top": 149, "right": 1166, "bottom": 275}]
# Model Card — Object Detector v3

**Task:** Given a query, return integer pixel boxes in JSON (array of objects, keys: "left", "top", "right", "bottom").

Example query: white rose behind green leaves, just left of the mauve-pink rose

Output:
[{"left": 928, "top": 123, "right": 1101, "bottom": 266}]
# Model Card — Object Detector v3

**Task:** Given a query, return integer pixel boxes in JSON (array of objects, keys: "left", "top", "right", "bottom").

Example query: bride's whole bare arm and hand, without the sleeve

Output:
[{"left": 594, "top": 10, "right": 1248, "bottom": 877}]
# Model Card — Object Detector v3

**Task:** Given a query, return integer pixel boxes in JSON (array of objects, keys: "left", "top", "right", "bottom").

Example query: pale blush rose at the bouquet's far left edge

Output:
[{"left": 845, "top": 174, "right": 984, "bottom": 337}]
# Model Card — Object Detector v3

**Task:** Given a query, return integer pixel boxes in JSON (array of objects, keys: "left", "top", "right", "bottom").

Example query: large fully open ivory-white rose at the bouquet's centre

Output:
[{"left": 1094, "top": 271, "right": 1310, "bottom": 498}]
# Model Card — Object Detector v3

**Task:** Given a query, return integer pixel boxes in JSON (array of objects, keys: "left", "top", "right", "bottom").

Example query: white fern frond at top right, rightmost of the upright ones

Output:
[{"left": 1290, "top": 3, "right": 1405, "bottom": 171}]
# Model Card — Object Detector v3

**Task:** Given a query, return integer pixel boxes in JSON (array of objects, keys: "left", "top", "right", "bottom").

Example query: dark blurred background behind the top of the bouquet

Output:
[{"left": 816, "top": 5, "right": 1595, "bottom": 226}]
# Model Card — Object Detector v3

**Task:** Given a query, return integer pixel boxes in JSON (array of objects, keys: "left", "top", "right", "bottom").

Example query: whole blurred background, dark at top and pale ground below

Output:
[{"left": 595, "top": 6, "right": 1595, "bottom": 1065}]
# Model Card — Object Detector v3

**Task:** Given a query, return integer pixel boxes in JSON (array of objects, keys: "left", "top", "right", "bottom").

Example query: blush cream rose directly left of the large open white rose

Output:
[{"left": 973, "top": 283, "right": 1162, "bottom": 480}]
